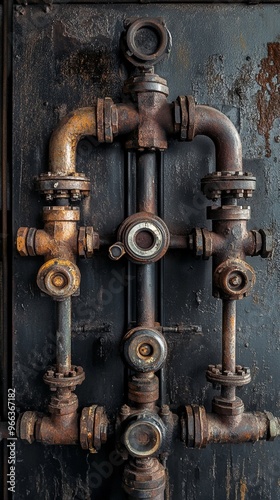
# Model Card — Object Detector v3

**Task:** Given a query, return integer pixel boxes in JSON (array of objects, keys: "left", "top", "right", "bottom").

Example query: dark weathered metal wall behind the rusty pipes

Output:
[{"left": 7, "top": 3, "right": 280, "bottom": 500}]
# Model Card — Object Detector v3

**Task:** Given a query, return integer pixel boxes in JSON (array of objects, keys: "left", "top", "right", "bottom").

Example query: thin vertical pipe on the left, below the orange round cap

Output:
[{"left": 56, "top": 297, "right": 71, "bottom": 373}]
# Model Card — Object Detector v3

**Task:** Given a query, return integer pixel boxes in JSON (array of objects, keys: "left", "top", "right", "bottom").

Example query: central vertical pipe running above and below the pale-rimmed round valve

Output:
[{"left": 137, "top": 152, "right": 157, "bottom": 327}]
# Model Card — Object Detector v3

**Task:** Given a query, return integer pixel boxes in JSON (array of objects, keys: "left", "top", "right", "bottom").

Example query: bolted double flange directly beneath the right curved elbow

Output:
[{"left": 201, "top": 171, "right": 256, "bottom": 200}]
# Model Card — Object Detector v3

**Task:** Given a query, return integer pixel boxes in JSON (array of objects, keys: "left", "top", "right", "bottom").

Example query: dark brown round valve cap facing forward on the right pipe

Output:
[{"left": 213, "top": 259, "right": 256, "bottom": 300}]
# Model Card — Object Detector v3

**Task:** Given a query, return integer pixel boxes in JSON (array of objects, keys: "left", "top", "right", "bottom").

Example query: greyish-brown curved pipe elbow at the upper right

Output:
[{"left": 194, "top": 105, "right": 242, "bottom": 172}]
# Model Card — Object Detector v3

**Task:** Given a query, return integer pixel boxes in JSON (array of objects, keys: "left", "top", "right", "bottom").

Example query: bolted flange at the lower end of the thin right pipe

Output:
[{"left": 206, "top": 365, "right": 251, "bottom": 387}]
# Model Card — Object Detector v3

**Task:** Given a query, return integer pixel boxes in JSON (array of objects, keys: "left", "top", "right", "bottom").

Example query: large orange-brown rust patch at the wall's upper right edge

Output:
[{"left": 256, "top": 42, "right": 280, "bottom": 157}]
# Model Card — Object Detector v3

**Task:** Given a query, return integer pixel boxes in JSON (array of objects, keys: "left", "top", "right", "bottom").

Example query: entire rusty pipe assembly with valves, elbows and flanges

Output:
[{"left": 17, "top": 18, "right": 280, "bottom": 500}]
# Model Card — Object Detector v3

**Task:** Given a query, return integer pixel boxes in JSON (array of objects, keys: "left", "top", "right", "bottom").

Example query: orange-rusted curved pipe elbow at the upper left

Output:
[{"left": 49, "top": 106, "right": 96, "bottom": 176}]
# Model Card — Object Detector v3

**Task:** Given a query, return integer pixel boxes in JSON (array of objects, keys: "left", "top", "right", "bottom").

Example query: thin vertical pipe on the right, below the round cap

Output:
[{"left": 221, "top": 299, "right": 236, "bottom": 401}]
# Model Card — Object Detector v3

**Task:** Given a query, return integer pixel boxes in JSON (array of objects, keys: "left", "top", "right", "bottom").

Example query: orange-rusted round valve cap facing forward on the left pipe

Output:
[{"left": 37, "top": 259, "right": 81, "bottom": 300}]
